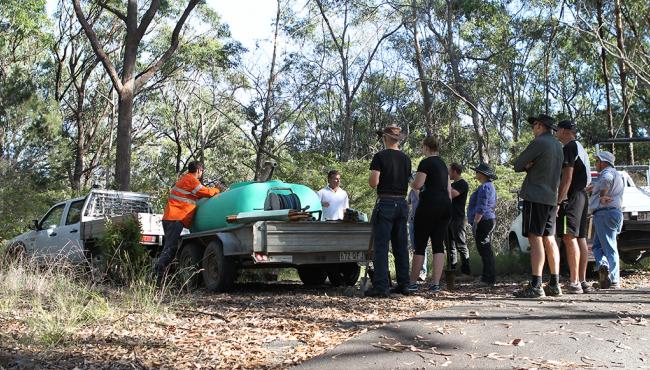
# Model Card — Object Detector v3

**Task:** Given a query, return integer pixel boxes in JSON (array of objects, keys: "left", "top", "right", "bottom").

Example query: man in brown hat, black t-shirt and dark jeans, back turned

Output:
[{"left": 365, "top": 125, "right": 411, "bottom": 297}]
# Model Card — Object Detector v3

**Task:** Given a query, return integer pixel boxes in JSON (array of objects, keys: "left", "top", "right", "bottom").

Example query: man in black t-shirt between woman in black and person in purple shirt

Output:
[{"left": 447, "top": 163, "right": 470, "bottom": 275}]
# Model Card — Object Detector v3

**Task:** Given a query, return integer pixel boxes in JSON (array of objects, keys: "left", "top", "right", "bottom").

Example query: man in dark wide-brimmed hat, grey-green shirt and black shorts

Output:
[{"left": 514, "top": 114, "right": 564, "bottom": 298}]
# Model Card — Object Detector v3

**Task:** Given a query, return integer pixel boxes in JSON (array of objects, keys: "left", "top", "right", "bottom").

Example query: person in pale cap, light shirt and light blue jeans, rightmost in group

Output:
[{"left": 587, "top": 151, "right": 625, "bottom": 289}]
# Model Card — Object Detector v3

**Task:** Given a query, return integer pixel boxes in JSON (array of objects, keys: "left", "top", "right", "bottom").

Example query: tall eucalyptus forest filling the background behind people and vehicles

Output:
[{"left": 0, "top": 0, "right": 650, "bottom": 242}]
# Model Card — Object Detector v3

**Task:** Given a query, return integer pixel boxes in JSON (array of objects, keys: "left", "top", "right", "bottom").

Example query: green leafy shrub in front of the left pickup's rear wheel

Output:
[{"left": 96, "top": 216, "right": 151, "bottom": 286}]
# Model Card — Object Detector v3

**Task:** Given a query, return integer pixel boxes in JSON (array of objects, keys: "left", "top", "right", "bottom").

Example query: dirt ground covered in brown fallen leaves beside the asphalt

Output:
[{"left": 0, "top": 271, "right": 650, "bottom": 369}]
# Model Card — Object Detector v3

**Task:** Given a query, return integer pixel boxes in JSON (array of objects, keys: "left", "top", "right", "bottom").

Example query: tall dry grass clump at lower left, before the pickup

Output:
[{"left": 0, "top": 254, "right": 176, "bottom": 347}]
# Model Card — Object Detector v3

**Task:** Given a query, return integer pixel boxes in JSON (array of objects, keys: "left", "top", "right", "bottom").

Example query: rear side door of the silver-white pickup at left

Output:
[{"left": 56, "top": 199, "right": 85, "bottom": 262}]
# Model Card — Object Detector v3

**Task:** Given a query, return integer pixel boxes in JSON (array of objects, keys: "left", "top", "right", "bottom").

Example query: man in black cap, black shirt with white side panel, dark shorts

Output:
[{"left": 557, "top": 120, "right": 591, "bottom": 294}]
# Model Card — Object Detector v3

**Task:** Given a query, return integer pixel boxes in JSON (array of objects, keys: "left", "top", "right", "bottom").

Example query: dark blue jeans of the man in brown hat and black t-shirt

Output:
[{"left": 372, "top": 198, "right": 409, "bottom": 292}]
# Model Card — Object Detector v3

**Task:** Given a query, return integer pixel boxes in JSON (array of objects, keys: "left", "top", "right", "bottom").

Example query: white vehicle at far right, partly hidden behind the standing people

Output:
[{"left": 508, "top": 166, "right": 650, "bottom": 263}]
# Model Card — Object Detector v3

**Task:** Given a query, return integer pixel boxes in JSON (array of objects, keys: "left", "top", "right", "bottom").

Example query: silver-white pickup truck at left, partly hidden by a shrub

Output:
[{"left": 8, "top": 190, "right": 164, "bottom": 262}]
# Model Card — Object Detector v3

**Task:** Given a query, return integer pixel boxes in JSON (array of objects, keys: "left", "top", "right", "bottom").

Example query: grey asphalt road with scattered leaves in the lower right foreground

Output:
[{"left": 298, "top": 288, "right": 650, "bottom": 369}]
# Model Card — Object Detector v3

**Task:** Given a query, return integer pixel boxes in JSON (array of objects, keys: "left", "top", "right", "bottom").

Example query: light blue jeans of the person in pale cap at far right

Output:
[{"left": 591, "top": 209, "right": 623, "bottom": 284}]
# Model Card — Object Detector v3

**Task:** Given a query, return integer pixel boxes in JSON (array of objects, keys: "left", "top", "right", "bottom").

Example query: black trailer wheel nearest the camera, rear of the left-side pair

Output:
[{"left": 202, "top": 240, "right": 237, "bottom": 292}]
